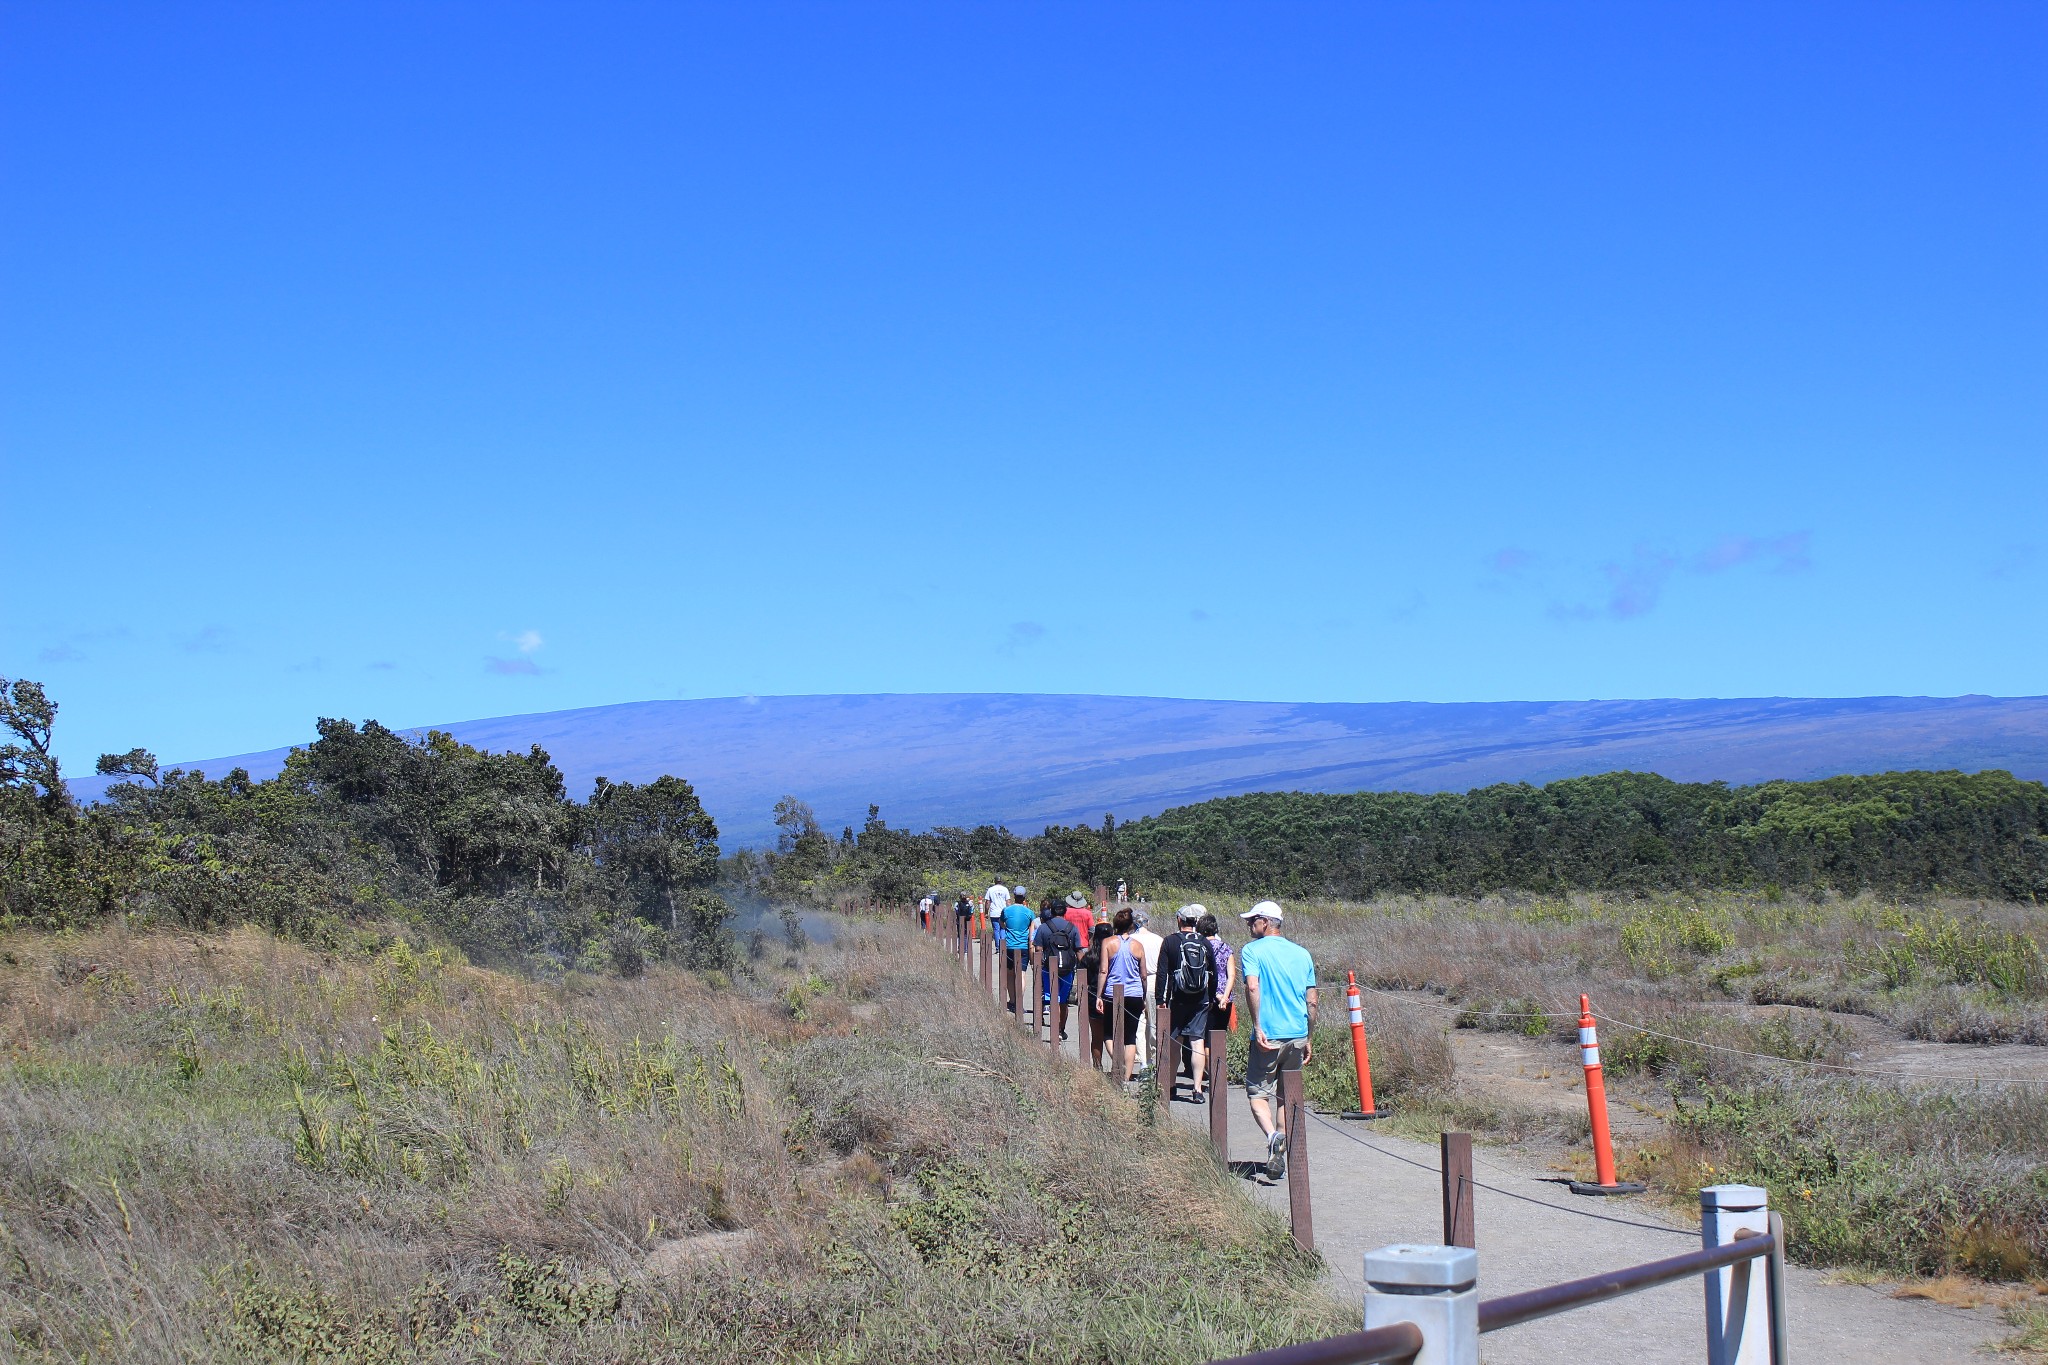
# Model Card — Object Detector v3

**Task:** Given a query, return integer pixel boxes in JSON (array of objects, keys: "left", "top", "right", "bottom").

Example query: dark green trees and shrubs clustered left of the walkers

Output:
[{"left": 0, "top": 679, "right": 735, "bottom": 970}]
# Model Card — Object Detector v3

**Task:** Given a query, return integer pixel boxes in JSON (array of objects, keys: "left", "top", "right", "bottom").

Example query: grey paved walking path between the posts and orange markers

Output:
[{"left": 1171, "top": 1087, "right": 2005, "bottom": 1365}]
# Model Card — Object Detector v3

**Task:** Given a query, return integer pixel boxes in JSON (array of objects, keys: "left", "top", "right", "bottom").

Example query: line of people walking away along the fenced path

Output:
[{"left": 954, "top": 884, "right": 1315, "bottom": 1179}]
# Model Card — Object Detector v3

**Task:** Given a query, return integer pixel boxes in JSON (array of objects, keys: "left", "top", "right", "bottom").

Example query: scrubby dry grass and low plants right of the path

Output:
[{"left": 1245, "top": 892, "right": 2048, "bottom": 1281}]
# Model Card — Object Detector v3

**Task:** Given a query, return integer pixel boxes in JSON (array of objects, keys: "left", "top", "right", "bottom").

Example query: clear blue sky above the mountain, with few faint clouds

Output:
[{"left": 0, "top": 0, "right": 2048, "bottom": 772}]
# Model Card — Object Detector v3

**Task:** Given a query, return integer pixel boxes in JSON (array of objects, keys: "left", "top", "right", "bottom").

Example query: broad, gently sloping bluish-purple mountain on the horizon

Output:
[{"left": 76, "top": 694, "right": 2048, "bottom": 847}]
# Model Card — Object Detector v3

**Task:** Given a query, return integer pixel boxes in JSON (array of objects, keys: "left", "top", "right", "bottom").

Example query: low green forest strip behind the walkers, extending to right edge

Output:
[{"left": 768, "top": 772, "right": 2048, "bottom": 900}]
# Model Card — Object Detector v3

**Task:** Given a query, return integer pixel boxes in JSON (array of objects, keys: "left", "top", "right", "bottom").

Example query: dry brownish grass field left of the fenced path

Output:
[{"left": 0, "top": 925, "right": 1343, "bottom": 1361}]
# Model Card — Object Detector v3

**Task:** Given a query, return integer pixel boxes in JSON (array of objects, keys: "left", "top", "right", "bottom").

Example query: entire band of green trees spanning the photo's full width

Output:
[{"left": 12, "top": 679, "right": 2048, "bottom": 970}]
